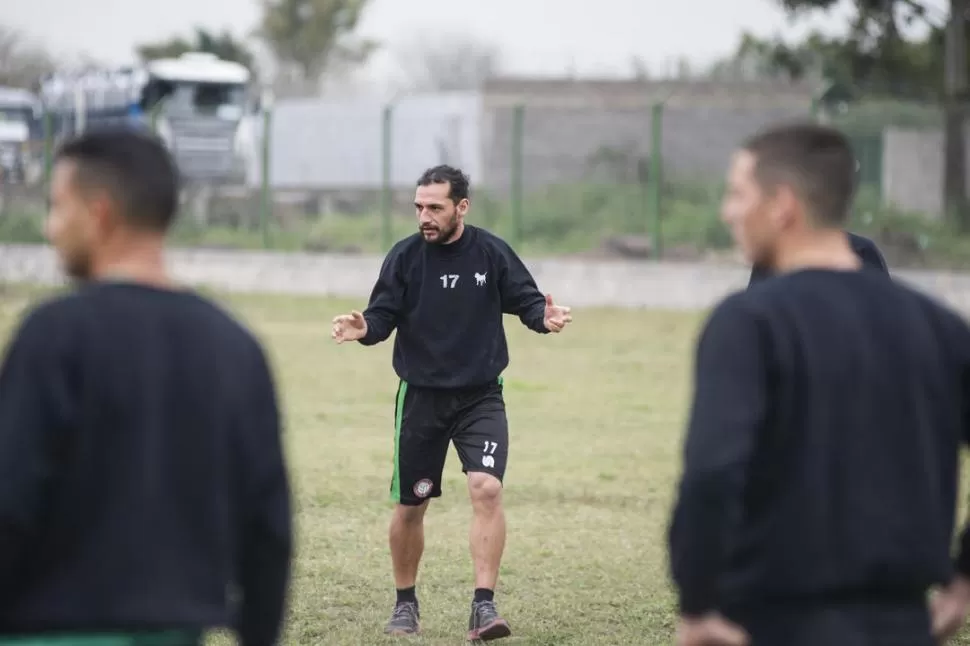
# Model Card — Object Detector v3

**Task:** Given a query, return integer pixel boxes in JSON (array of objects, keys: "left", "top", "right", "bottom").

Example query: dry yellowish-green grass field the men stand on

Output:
[{"left": 0, "top": 291, "right": 970, "bottom": 646}]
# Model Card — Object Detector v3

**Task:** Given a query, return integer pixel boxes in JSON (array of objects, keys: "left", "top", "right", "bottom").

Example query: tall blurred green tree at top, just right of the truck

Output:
[{"left": 257, "top": 0, "right": 376, "bottom": 82}]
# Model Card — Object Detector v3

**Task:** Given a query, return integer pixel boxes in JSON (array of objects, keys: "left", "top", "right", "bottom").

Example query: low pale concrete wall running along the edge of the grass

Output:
[{"left": 0, "top": 246, "right": 970, "bottom": 314}]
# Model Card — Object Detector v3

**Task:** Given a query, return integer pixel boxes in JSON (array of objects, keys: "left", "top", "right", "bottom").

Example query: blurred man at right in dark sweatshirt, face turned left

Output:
[{"left": 669, "top": 124, "right": 970, "bottom": 646}]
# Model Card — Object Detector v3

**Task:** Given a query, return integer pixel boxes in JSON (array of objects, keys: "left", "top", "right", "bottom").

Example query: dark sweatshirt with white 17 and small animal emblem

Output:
[{"left": 360, "top": 225, "right": 547, "bottom": 388}]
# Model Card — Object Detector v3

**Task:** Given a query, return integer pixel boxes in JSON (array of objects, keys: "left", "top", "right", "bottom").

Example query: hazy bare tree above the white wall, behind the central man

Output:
[{"left": 398, "top": 35, "right": 501, "bottom": 92}]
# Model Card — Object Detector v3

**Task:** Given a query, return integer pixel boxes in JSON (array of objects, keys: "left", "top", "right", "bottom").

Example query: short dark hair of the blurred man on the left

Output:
[{"left": 55, "top": 127, "right": 179, "bottom": 233}]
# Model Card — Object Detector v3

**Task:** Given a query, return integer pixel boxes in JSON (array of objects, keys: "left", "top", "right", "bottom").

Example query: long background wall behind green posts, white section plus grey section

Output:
[{"left": 247, "top": 79, "right": 811, "bottom": 193}]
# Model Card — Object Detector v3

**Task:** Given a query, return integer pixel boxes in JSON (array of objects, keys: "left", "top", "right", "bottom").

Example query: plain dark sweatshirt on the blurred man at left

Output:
[{"left": 0, "top": 283, "right": 291, "bottom": 646}]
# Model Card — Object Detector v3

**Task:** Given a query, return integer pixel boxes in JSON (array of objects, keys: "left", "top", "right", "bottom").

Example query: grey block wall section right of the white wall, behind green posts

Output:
[{"left": 481, "top": 79, "right": 811, "bottom": 193}]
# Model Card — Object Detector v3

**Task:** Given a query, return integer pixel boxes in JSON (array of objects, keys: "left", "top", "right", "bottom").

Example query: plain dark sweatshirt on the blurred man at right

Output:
[{"left": 669, "top": 269, "right": 970, "bottom": 615}]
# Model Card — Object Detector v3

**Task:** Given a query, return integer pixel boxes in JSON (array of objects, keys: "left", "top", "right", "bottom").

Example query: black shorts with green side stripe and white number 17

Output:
[{"left": 391, "top": 377, "right": 509, "bottom": 506}]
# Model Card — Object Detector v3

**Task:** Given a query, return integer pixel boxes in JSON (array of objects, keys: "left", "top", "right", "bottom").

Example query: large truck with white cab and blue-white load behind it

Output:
[{"left": 40, "top": 52, "right": 252, "bottom": 186}]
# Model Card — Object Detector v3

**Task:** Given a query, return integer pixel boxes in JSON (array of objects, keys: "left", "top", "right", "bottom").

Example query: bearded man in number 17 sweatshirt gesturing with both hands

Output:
[{"left": 333, "top": 166, "right": 572, "bottom": 640}]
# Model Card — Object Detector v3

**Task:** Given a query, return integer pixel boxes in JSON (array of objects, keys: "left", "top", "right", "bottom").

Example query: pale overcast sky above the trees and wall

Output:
[{"left": 0, "top": 0, "right": 947, "bottom": 83}]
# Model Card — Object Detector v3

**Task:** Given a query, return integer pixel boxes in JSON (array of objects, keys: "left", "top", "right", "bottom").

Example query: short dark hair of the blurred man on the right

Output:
[{"left": 743, "top": 123, "right": 856, "bottom": 227}]
